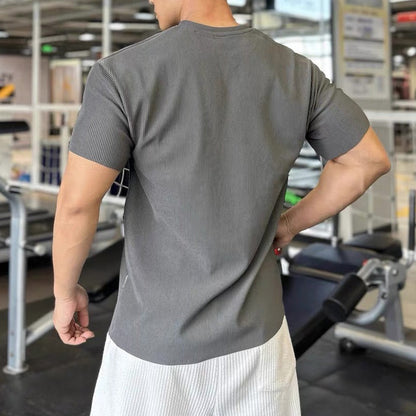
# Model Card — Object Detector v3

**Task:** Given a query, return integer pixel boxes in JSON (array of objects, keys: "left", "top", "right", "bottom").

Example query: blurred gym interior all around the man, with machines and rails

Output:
[{"left": 0, "top": 0, "right": 416, "bottom": 416}]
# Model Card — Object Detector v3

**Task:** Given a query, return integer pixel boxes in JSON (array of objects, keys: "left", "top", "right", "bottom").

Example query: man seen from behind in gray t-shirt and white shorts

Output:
[{"left": 53, "top": 0, "right": 390, "bottom": 416}]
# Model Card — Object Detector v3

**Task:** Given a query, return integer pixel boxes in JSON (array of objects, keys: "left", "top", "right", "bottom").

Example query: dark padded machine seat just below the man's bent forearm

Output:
[{"left": 289, "top": 243, "right": 388, "bottom": 282}]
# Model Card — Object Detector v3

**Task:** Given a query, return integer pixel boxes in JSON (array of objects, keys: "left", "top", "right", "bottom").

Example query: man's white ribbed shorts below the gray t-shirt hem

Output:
[{"left": 90, "top": 318, "right": 301, "bottom": 416}]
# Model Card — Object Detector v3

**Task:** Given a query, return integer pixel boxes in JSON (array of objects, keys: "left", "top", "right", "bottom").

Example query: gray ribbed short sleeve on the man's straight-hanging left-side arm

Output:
[{"left": 69, "top": 62, "right": 133, "bottom": 171}]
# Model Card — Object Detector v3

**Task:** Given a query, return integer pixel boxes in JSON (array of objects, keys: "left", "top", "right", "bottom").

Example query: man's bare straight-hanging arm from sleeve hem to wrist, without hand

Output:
[{"left": 52, "top": 152, "right": 119, "bottom": 299}]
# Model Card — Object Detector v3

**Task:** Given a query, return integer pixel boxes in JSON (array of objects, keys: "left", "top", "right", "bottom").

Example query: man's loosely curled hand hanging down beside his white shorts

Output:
[{"left": 53, "top": 284, "right": 95, "bottom": 345}]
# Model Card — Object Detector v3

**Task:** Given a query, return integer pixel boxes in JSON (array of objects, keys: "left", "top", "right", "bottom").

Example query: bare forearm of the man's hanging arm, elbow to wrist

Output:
[{"left": 52, "top": 205, "right": 99, "bottom": 298}]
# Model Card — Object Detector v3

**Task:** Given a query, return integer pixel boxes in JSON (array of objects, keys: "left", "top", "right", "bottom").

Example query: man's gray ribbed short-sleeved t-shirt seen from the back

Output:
[{"left": 70, "top": 20, "right": 370, "bottom": 365}]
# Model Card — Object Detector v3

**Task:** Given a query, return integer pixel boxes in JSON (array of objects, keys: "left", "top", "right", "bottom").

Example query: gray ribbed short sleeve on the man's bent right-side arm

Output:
[{"left": 305, "top": 61, "right": 370, "bottom": 160}]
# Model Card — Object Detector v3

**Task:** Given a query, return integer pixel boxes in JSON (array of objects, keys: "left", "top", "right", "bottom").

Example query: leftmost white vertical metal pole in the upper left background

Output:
[{"left": 31, "top": 1, "right": 41, "bottom": 185}]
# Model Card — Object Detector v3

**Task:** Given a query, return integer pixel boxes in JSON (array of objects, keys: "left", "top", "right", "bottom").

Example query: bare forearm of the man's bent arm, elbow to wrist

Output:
[{"left": 283, "top": 161, "right": 386, "bottom": 234}]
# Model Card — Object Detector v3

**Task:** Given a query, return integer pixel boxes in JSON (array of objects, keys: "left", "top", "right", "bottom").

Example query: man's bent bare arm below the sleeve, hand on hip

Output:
[{"left": 276, "top": 127, "right": 390, "bottom": 247}]
